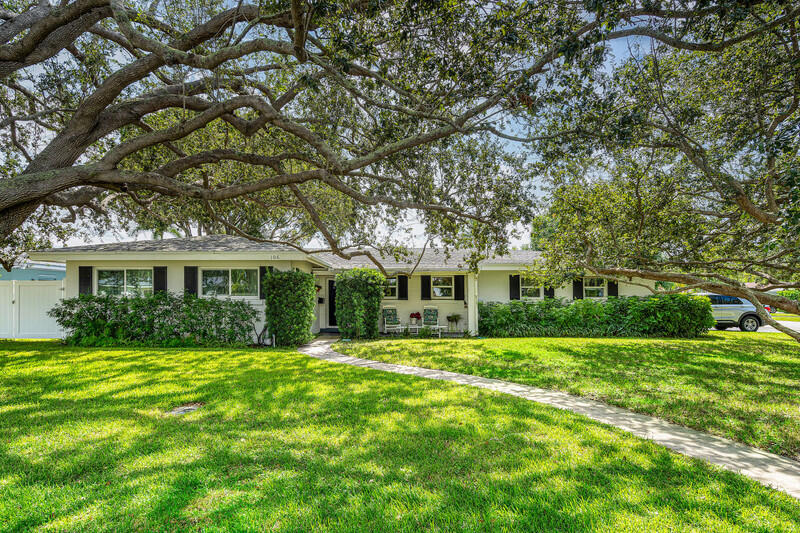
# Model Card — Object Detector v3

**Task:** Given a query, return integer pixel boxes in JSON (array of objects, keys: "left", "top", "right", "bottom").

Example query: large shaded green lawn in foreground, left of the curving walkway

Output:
[{"left": 0, "top": 340, "right": 800, "bottom": 532}]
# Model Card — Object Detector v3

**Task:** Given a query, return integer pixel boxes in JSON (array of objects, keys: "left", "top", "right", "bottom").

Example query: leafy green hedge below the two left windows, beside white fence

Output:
[{"left": 48, "top": 292, "right": 258, "bottom": 347}]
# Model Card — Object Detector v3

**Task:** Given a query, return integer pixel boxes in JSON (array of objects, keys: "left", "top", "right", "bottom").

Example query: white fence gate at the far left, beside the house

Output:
[{"left": 0, "top": 280, "right": 64, "bottom": 339}]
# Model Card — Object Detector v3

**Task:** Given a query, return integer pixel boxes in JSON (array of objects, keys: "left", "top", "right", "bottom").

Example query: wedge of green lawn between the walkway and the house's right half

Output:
[{"left": 338, "top": 332, "right": 800, "bottom": 459}]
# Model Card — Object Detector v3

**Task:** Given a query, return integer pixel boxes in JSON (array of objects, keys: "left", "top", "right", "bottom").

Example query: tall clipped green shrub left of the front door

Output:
[{"left": 262, "top": 270, "right": 317, "bottom": 346}]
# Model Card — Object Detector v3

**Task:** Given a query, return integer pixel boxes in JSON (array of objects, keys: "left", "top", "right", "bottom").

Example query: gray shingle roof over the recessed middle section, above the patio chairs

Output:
[{"left": 315, "top": 248, "right": 540, "bottom": 272}]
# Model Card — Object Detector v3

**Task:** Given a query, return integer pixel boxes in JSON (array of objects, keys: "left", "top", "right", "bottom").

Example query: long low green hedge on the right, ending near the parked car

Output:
[{"left": 478, "top": 294, "right": 714, "bottom": 338}]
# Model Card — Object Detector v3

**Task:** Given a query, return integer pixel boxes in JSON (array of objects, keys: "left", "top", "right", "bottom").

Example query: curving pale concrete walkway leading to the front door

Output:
[{"left": 300, "top": 338, "right": 800, "bottom": 499}]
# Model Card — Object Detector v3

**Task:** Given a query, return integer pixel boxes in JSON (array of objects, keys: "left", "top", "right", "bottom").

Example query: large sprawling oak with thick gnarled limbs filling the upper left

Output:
[{"left": 0, "top": 0, "right": 794, "bottom": 266}]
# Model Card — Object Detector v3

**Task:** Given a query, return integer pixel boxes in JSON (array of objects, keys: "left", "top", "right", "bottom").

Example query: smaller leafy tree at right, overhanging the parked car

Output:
[{"left": 538, "top": 9, "right": 800, "bottom": 340}]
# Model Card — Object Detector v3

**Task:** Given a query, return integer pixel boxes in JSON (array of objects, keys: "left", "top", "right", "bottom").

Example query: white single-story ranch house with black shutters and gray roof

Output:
[{"left": 29, "top": 235, "right": 652, "bottom": 333}]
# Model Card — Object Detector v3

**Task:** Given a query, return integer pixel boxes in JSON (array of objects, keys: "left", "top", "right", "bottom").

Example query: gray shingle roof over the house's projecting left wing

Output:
[{"left": 38, "top": 235, "right": 296, "bottom": 252}]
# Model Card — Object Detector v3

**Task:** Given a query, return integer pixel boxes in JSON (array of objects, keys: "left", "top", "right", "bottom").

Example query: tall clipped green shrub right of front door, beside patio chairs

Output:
[{"left": 336, "top": 268, "right": 386, "bottom": 339}]
